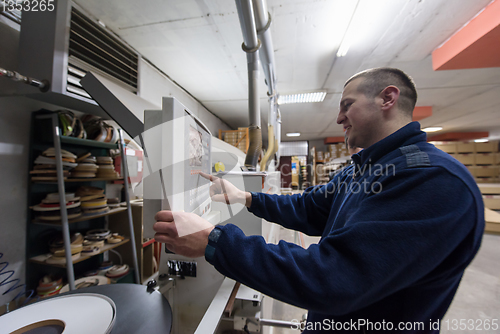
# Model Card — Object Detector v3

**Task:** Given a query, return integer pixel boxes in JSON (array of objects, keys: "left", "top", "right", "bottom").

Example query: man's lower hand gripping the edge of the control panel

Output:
[{"left": 153, "top": 210, "right": 214, "bottom": 258}]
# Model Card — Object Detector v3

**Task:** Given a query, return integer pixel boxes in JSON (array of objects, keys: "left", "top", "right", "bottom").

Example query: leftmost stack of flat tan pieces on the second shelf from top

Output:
[{"left": 30, "top": 147, "right": 78, "bottom": 181}]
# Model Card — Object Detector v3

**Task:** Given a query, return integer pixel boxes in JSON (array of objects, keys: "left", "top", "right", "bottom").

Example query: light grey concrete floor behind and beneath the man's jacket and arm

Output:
[{"left": 265, "top": 228, "right": 500, "bottom": 334}]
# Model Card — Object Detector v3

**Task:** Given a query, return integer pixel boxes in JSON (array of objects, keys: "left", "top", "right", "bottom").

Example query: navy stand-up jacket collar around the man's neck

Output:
[{"left": 352, "top": 122, "right": 427, "bottom": 173}]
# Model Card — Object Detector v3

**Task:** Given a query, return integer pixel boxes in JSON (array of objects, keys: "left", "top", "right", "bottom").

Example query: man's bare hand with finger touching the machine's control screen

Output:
[{"left": 200, "top": 172, "right": 252, "bottom": 207}]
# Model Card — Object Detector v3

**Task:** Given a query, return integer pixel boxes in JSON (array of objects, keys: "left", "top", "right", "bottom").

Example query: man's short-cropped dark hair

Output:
[{"left": 344, "top": 67, "right": 417, "bottom": 116}]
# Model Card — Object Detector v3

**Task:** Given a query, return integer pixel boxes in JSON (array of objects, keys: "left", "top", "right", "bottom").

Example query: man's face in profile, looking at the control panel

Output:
[{"left": 337, "top": 78, "right": 379, "bottom": 148}]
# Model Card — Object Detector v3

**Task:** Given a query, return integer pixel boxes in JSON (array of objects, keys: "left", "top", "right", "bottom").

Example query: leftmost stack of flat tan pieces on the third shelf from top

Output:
[{"left": 33, "top": 193, "right": 82, "bottom": 221}]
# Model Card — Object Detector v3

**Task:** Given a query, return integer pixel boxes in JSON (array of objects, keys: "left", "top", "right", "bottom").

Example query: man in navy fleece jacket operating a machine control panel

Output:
[{"left": 155, "top": 68, "right": 484, "bottom": 333}]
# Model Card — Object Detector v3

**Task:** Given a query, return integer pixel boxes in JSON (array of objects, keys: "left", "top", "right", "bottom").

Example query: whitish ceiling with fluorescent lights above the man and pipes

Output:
[{"left": 75, "top": 0, "right": 500, "bottom": 141}]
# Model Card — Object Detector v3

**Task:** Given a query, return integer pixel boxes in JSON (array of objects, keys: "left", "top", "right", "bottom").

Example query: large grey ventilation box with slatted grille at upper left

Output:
[{"left": 19, "top": 0, "right": 139, "bottom": 118}]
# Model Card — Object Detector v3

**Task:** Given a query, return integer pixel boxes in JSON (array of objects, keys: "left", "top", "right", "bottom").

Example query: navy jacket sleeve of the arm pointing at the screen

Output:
[{"left": 248, "top": 171, "right": 348, "bottom": 236}]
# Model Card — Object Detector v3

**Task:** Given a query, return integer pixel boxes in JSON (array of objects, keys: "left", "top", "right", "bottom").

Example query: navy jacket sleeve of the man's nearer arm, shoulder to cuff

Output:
[{"left": 207, "top": 167, "right": 481, "bottom": 315}]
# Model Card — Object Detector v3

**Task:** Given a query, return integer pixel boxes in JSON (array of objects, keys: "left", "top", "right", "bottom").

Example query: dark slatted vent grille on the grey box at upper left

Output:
[{"left": 67, "top": 8, "right": 139, "bottom": 97}]
